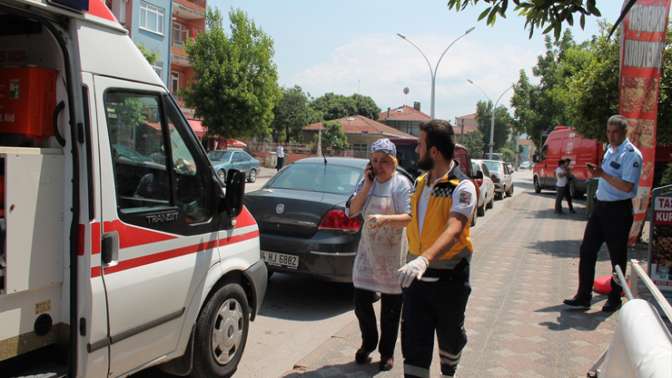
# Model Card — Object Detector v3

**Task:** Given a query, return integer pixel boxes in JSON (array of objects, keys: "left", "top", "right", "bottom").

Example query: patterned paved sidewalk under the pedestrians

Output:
[{"left": 284, "top": 182, "right": 642, "bottom": 377}]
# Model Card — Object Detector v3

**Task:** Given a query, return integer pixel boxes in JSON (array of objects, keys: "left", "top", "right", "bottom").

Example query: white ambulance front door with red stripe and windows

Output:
[{"left": 92, "top": 76, "right": 221, "bottom": 376}]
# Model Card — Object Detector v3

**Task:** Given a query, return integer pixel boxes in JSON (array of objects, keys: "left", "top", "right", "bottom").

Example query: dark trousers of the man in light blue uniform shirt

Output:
[{"left": 577, "top": 200, "right": 632, "bottom": 301}]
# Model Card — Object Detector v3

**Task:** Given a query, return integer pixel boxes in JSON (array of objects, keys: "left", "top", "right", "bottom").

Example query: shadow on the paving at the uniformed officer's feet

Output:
[{"left": 535, "top": 302, "right": 611, "bottom": 331}]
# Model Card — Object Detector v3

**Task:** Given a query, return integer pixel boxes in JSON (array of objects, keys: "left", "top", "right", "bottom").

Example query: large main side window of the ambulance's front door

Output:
[{"left": 105, "top": 91, "right": 170, "bottom": 214}]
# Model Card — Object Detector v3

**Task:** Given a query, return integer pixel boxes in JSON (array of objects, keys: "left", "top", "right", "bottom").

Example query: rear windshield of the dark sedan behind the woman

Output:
[{"left": 267, "top": 164, "right": 362, "bottom": 194}]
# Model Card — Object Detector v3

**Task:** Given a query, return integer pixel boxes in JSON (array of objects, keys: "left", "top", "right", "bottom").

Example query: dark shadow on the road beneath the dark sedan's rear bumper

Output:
[{"left": 259, "top": 272, "right": 353, "bottom": 321}]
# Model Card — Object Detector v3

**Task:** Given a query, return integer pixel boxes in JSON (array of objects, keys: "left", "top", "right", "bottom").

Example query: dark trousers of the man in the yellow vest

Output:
[{"left": 401, "top": 264, "right": 471, "bottom": 377}]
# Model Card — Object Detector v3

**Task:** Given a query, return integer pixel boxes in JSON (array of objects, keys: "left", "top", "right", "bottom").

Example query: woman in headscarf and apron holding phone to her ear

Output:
[{"left": 348, "top": 138, "right": 412, "bottom": 370}]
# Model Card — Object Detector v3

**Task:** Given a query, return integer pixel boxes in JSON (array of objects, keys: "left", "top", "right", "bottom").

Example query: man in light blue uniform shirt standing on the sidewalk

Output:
[{"left": 564, "top": 115, "right": 642, "bottom": 312}]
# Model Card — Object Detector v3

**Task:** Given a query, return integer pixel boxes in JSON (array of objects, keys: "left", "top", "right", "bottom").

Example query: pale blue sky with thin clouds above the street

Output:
[{"left": 209, "top": 0, "right": 621, "bottom": 122}]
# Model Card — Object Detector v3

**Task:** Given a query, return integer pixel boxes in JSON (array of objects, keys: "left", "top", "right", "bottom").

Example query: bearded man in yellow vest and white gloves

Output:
[{"left": 399, "top": 120, "right": 476, "bottom": 377}]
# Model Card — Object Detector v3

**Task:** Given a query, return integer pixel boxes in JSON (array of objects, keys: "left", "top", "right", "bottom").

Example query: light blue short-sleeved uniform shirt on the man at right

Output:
[{"left": 597, "top": 139, "right": 642, "bottom": 201}]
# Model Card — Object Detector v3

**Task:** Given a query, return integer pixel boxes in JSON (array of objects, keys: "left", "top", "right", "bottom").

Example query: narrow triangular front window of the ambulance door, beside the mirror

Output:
[{"left": 167, "top": 101, "right": 212, "bottom": 224}]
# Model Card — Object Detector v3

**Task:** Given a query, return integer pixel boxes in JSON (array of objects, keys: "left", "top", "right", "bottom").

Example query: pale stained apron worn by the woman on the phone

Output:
[{"left": 352, "top": 195, "right": 407, "bottom": 294}]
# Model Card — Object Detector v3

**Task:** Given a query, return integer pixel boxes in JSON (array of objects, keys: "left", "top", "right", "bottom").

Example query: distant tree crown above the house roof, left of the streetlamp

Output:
[{"left": 311, "top": 92, "right": 380, "bottom": 121}]
